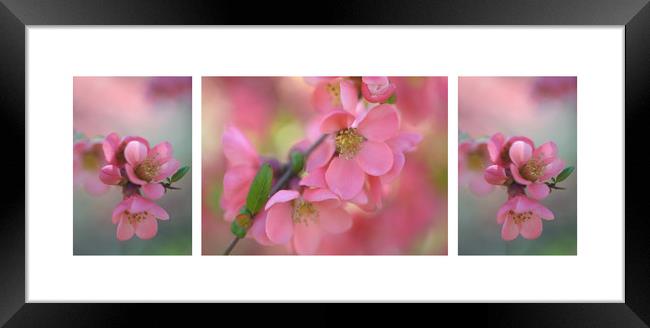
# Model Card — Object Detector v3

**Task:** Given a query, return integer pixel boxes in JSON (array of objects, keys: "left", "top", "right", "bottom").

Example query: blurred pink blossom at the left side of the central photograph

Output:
[{"left": 221, "top": 126, "right": 261, "bottom": 222}]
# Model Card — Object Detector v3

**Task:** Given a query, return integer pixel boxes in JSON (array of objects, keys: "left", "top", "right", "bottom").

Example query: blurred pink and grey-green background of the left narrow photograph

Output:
[{"left": 73, "top": 77, "right": 194, "bottom": 255}]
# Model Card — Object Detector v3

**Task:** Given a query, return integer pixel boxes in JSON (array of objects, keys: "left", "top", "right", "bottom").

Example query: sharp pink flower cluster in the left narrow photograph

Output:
[{"left": 99, "top": 133, "right": 180, "bottom": 240}]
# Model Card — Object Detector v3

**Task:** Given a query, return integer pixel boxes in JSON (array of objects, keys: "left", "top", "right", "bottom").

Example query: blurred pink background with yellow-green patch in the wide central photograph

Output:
[{"left": 202, "top": 77, "right": 447, "bottom": 255}]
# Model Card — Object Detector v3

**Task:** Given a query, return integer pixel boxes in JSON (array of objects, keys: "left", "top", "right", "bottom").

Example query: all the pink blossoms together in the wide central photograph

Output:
[{"left": 221, "top": 77, "right": 421, "bottom": 254}]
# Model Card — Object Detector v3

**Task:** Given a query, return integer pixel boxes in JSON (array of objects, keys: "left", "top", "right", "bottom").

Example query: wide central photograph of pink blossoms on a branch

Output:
[{"left": 202, "top": 76, "right": 448, "bottom": 255}]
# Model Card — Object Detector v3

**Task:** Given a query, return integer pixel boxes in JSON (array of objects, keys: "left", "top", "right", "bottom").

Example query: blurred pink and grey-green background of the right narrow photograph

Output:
[{"left": 458, "top": 77, "right": 580, "bottom": 255}]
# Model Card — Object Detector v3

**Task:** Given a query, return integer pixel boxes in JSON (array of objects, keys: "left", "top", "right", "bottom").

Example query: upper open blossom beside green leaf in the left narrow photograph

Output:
[{"left": 124, "top": 140, "right": 180, "bottom": 199}]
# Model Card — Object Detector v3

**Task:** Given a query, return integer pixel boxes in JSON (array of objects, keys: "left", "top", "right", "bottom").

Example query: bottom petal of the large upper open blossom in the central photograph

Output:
[{"left": 325, "top": 157, "right": 365, "bottom": 200}]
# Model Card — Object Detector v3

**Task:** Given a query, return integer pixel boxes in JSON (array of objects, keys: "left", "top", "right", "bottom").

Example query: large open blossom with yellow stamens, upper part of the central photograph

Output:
[{"left": 311, "top": 104, "right": 400, "bottom": 200}]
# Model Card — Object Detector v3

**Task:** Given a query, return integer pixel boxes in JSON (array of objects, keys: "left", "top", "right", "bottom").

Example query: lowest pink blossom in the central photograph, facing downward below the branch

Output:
[{"left": 265, "top": 189, "right": 352, "bottom": 255}]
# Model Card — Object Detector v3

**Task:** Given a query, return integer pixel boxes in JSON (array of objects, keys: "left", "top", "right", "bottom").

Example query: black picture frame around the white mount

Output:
[{"left": 0, "top": 0, "right": 650, "bottom": 327}]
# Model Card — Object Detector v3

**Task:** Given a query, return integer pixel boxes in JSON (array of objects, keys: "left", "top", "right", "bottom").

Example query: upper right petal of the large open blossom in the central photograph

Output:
[{"left": 358, "top": 104, "right": 399, "bottom": 141}]
